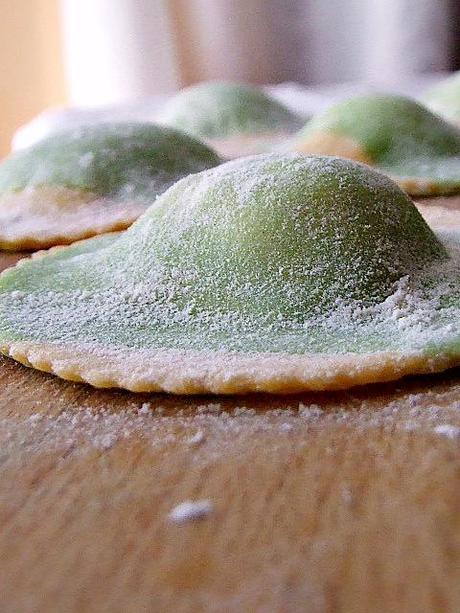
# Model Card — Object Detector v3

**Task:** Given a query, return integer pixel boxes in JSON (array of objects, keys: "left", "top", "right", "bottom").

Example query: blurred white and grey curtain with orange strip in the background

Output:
[{"left": 0, "top": 0, "right": 460, "bottom": 155}]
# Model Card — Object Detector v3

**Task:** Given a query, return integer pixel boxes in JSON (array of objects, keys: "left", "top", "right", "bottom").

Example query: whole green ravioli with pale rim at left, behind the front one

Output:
[{"left": 0, "top": 123, "right": 220, "bottom": 249}]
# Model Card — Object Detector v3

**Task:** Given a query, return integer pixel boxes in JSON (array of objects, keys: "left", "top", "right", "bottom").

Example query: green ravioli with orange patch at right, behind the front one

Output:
[{"left": 289, "top": 95, "right": 460, "bottom": 195}]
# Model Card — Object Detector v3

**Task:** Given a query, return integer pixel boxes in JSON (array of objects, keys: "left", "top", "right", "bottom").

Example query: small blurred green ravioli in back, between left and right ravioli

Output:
[{"left": 158, "top": 82, "right": 305, "bottom": 157}]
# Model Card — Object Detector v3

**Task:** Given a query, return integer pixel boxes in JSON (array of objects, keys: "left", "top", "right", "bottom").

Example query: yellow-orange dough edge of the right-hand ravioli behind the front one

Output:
[{"left": 292, "top": 131, "right": 458, "bottom": 196}]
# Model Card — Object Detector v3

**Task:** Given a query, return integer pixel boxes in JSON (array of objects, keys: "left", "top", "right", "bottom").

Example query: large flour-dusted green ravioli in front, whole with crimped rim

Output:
[{"left": 0, "top": 154, "right": 460, "bottom": 393}]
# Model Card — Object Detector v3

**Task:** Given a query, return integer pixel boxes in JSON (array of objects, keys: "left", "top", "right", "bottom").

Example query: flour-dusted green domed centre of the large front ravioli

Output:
[{"left": 132, "top": 155, "right": 444, "bottom": 318}]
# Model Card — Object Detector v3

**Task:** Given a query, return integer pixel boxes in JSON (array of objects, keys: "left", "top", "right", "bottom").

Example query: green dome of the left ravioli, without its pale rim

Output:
[{"left": 0, "top": 122, "right": 220, "bottom": 204}]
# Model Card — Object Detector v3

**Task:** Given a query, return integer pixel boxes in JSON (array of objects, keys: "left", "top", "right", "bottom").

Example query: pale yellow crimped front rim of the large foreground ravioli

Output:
[{"left": 0, "top": 341, "right": 460, "bottom": 394}]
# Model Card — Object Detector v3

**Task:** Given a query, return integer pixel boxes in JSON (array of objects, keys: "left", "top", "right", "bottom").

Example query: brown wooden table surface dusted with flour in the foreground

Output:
[{"left": 0, "top": 237, "right": 460, "bottom": 613}]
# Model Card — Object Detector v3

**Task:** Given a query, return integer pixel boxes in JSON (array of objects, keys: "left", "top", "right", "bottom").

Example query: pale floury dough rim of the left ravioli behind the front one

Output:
[{"left": 0, "top": 186, "right": 147, "bottom": 251}]
